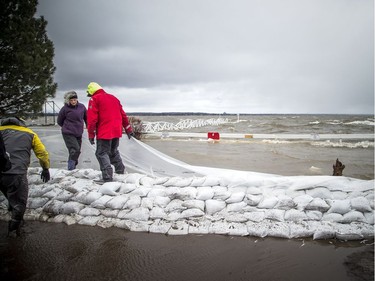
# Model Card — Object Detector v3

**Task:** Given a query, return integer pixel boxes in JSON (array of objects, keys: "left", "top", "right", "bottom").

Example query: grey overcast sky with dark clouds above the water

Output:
[{"left": 38, "top": 0, "right": 374, "bottom": 114}]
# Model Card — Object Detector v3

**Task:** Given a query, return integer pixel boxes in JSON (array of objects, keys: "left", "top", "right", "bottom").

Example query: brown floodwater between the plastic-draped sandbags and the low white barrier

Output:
[{"left": 143, "top": 138, "right": 374, "bottom": 180}]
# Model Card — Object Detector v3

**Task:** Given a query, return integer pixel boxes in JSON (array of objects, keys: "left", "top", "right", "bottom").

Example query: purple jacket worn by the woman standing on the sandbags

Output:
[{"left": 57, "top": 103, "right": 87, "bottom": 137}]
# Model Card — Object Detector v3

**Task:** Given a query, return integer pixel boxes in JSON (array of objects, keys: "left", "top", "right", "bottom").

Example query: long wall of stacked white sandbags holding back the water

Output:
[{"left": 0, "top": 168, "right": 374, "bottom": 240}]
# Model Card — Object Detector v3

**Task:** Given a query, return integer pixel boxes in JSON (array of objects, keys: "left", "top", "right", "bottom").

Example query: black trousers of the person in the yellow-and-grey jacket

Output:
[{"left": 0, "top": 174, "right": 29, "bottom": 221}]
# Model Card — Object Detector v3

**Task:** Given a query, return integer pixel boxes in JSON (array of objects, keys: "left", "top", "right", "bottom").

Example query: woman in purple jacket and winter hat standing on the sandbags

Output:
[{"left": 57, "top": 91, "right": 87, "bottom": 170}]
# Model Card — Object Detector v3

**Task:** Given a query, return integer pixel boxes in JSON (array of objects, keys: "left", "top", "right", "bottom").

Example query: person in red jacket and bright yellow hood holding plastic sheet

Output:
[{"left": 87, "top": 82, "right": 134, "bottom": 182}]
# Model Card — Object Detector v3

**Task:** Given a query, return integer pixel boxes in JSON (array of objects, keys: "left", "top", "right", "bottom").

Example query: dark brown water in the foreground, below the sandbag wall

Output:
[{"left": 0, "top": 221, "right": 374, "bottom": 281}]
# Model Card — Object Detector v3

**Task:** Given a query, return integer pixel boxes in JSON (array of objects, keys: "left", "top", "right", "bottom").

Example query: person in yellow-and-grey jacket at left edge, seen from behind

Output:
[{"left": 0, "top": 117, "right": 50, "bottom": 236}]
